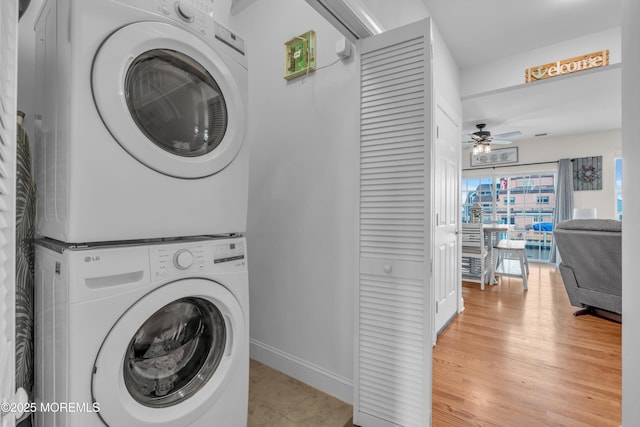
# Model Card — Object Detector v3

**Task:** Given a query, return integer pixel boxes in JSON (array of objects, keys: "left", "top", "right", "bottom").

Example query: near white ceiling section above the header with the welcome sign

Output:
[{"left": 423, "top": 0, "right": 622, "bottom": 69}]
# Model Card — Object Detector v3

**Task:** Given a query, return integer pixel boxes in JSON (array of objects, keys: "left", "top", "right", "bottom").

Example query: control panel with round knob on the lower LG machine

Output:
[{"left": 149, "top": 238, "right": 247, "bottom": 279}]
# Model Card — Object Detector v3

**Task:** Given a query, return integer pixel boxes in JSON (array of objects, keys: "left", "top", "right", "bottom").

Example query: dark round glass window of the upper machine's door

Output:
[{"left": 124, "top": 49, "right": 227, "bottom": 157}]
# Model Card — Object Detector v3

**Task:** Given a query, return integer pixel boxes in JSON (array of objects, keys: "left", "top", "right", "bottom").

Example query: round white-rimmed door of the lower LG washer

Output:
[{"left": 91, "top": 279, "right": 248, "bottom": 427}]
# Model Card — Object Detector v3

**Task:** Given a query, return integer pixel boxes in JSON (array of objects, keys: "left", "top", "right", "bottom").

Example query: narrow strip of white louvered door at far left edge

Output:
[{"left": 0, "top": 0, "right": 18, "bottom": 427}]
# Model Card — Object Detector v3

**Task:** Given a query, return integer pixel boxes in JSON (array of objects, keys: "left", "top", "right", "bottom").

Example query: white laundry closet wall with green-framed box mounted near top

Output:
[{"left": 230, "top": 0, "right": 359, "bottom": 401}]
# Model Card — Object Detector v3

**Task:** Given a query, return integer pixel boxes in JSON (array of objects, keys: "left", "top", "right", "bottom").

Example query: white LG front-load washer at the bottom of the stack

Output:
[{"left": 35, "top": 238, "right": 249, "bottom": 427}]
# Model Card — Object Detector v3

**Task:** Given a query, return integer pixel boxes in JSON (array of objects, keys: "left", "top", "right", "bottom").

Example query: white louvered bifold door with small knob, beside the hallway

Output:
[{"left": 354, "top": 20, "right": 432, "bottom": 427}]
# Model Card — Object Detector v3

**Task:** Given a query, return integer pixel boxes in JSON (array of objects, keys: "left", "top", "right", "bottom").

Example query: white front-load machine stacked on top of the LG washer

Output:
[{"left": 35, "top": 0, "right": 249, "bottom": 243}]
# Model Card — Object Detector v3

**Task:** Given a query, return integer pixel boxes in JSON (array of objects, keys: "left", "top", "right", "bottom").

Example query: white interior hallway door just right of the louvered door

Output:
[{"left": 433, "top": 99, "right": 461, "bottom": 333}]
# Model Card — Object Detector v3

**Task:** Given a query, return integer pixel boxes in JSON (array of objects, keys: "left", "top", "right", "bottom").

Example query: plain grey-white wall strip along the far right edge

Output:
[{"left": 622, "top": 0, "right": 640, "bottom": 427}]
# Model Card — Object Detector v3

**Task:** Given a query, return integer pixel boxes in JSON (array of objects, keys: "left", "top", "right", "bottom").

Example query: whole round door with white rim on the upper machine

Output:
[{"left": 88, "top": 22, "right": 246, "bottom": 179}]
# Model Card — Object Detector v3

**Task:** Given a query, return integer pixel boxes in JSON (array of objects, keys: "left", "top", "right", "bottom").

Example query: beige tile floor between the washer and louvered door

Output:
[{"left": 248, "top": 359, "right": 353, "bottom": 427}]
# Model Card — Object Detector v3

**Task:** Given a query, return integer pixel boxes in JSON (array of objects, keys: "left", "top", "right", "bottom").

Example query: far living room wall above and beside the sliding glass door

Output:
[{"left": 462, "top": 130, "right": 626, "bottom": 218}]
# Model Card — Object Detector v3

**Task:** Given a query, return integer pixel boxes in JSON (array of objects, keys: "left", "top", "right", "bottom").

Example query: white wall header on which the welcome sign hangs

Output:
[{"left": 461, "top": 28, "right": 621, "bottom": 98}]
